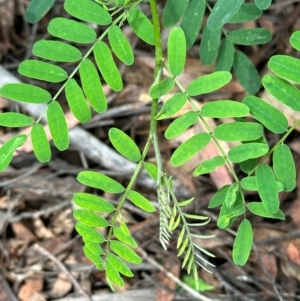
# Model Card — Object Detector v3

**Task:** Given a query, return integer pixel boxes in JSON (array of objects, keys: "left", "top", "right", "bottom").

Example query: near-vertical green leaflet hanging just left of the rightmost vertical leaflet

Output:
[{"left": 256, "top": 164, "right": 280, "bottom": 214}]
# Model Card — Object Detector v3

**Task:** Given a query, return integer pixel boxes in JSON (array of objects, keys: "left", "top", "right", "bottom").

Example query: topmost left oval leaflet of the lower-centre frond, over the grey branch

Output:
[{"left": 108, "top": 128, "right": 141, "bottom": 162}]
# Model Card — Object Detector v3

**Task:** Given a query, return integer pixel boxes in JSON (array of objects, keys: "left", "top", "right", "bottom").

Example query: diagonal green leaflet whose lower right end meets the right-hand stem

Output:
[{"left": 243, "top": 96, "right": 288, "bottom": 134}]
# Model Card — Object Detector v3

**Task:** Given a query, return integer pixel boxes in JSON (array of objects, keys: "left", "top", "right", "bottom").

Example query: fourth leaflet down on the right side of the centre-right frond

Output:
[{"left": 228, "top": 142, "right": 269, "bottom": 163}]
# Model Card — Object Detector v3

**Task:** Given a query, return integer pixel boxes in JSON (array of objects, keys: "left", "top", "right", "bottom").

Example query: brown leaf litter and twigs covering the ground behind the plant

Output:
[{"left": 0, "top": 0, "right": 300, "bottom": 301}]
